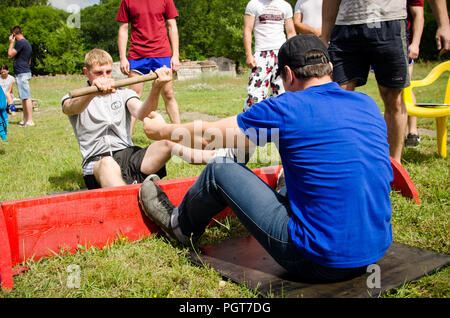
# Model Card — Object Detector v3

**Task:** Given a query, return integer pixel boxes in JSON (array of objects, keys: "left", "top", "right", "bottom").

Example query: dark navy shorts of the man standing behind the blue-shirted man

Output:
[{"left": 328, "top": 20, "right": 410, "bottom": 89}]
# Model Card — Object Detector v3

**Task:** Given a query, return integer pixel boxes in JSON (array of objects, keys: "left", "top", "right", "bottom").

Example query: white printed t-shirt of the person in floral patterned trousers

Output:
[{"left": 245, "top": 0, "right": 292, "bottom": 51}]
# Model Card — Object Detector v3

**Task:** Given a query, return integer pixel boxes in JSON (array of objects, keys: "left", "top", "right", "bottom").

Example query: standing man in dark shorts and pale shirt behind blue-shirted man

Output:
[{"left": 322, "top": 0, "right": 410, "bottom": 163}]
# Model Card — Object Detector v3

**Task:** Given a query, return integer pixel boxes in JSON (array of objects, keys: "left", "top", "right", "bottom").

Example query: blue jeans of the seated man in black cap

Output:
[{"left": 174, "top": 158, "right": 366, "bottom": 282}]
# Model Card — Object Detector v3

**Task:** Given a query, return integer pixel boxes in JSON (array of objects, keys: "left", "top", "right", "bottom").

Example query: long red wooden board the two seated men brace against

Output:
[{"left": 0, "top": 164, "right": 418, "bottom": 288}]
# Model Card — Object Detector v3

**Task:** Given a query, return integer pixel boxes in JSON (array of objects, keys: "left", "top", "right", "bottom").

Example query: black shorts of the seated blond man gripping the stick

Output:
[{"left": 84, "top": 146, "right": 167, "bottom": 190}]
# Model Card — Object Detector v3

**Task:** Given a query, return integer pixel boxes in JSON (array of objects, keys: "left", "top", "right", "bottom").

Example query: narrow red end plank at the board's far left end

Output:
[{"left": 0, "top": 204, "right": 14, "bottom": 291}]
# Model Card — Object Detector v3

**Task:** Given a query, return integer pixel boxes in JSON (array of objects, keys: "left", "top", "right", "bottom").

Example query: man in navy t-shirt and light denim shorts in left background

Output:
[{"left": 8, "top": 26, "right": 34, "bottom": 127}]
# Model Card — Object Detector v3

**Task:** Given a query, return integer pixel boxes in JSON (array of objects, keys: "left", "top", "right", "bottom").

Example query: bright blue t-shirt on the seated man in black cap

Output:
[{"left": 237, "top": 82, "right": 393, "bottom": 268}]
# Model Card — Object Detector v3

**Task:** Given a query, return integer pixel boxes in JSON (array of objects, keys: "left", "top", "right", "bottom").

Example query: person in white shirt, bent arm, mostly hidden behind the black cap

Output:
[{"left": 294, "top": 0, "right": 322, "bottom": 37}]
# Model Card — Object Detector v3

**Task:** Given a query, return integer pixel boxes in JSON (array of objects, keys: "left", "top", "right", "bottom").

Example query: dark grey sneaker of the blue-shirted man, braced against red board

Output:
[{"left": 139, "top": 176, "right": 178, "bottom": 241}]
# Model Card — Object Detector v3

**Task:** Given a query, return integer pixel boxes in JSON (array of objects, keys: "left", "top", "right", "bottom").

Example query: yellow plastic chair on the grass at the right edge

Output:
[{"left": 403, "top": 61, "right": 450, "bottom": 158}]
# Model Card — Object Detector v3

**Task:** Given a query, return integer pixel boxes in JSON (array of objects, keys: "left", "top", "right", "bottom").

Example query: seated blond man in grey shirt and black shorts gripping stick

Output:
[{"left": 62, "top": 49, "right": 214, "bottom": 189}]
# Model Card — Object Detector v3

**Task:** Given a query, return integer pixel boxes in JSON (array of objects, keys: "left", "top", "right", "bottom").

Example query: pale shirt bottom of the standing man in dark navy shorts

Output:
[{"left": 336, "top": 0, "right": 406, "bottom": 25}]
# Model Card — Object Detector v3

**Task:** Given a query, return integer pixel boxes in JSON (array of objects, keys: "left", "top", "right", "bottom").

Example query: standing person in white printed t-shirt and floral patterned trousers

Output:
[{"left": 244, "top": 0, "right": 296, "bottom": 111}]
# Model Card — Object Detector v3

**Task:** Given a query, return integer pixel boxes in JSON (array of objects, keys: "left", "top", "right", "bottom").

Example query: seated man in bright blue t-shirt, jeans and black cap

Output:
[{"left": 139, "top": 35, "right": 393, "bottom": 282}]
